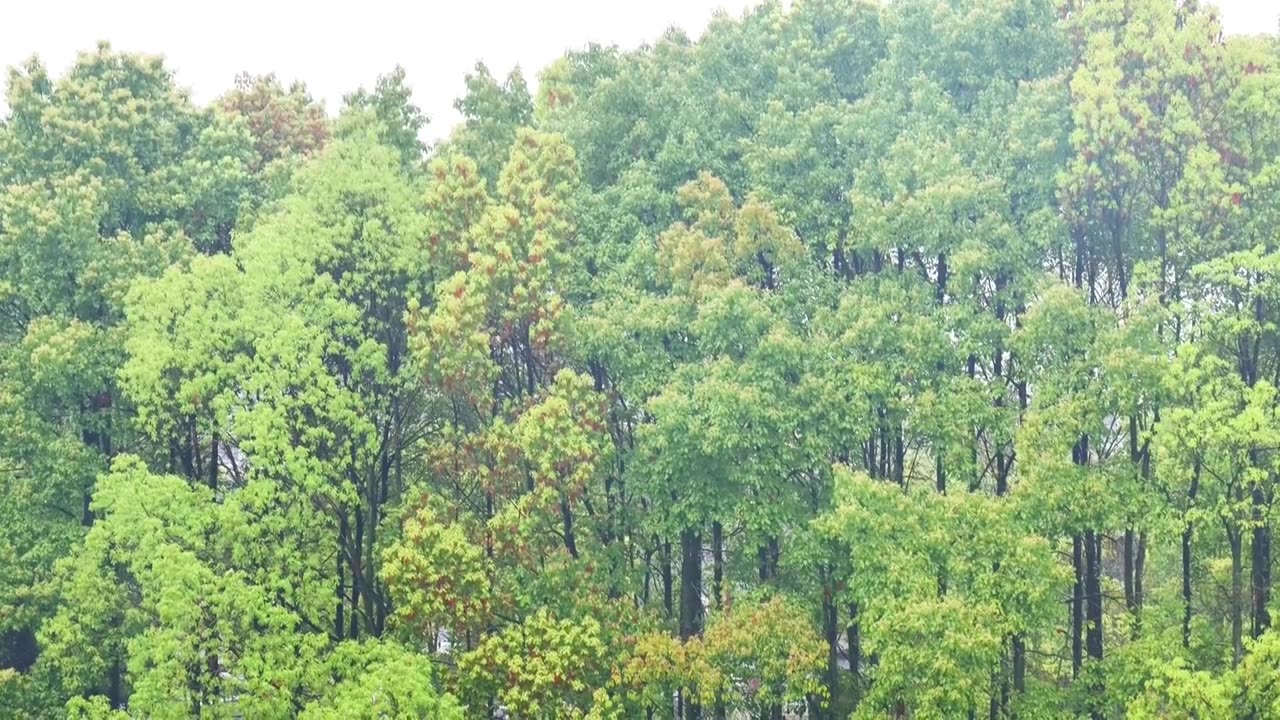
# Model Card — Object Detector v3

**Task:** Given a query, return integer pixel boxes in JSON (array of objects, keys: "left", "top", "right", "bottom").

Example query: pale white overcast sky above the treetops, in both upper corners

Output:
[{"left": 0, "top": 0, "right": 1280, "bottom": 138}]
